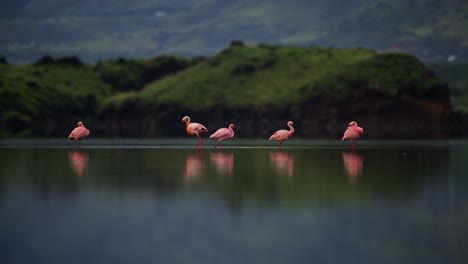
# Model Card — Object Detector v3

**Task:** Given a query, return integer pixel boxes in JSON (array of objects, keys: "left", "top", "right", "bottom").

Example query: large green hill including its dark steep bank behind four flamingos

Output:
[{"left": 99, "top": 42, "right": 452, "bottom": 137}]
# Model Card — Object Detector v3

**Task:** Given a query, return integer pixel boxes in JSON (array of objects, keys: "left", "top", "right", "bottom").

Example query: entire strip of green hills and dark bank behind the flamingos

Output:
[{"left": 0, "top": 41, "right": 462, "bottom": 136}]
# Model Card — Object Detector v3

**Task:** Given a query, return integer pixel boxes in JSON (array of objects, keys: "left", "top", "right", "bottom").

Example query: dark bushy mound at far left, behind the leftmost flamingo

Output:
[{"left": 0, "top": 58, "right": 111, "bottom": 135}]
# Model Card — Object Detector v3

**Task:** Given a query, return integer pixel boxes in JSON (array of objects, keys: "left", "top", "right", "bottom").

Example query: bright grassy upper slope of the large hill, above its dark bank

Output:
[{"left": 104, "top": 42, "right": 448, "bottom": 110}]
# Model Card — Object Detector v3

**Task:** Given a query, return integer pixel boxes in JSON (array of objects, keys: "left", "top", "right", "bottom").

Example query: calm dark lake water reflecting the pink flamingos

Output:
[{"left": 0, "top": 138, "right": 468, "bottom": 264}]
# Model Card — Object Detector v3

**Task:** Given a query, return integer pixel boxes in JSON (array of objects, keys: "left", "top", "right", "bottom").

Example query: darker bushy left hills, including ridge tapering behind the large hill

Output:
[{"left": 0, "top": 56, "right": 192, "bottom": 136}]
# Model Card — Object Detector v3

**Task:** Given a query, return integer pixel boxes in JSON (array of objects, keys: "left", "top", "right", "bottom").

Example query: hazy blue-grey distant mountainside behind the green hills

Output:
[{"left": 0, "top": 0, "right": 468, "bottom": 62}]
